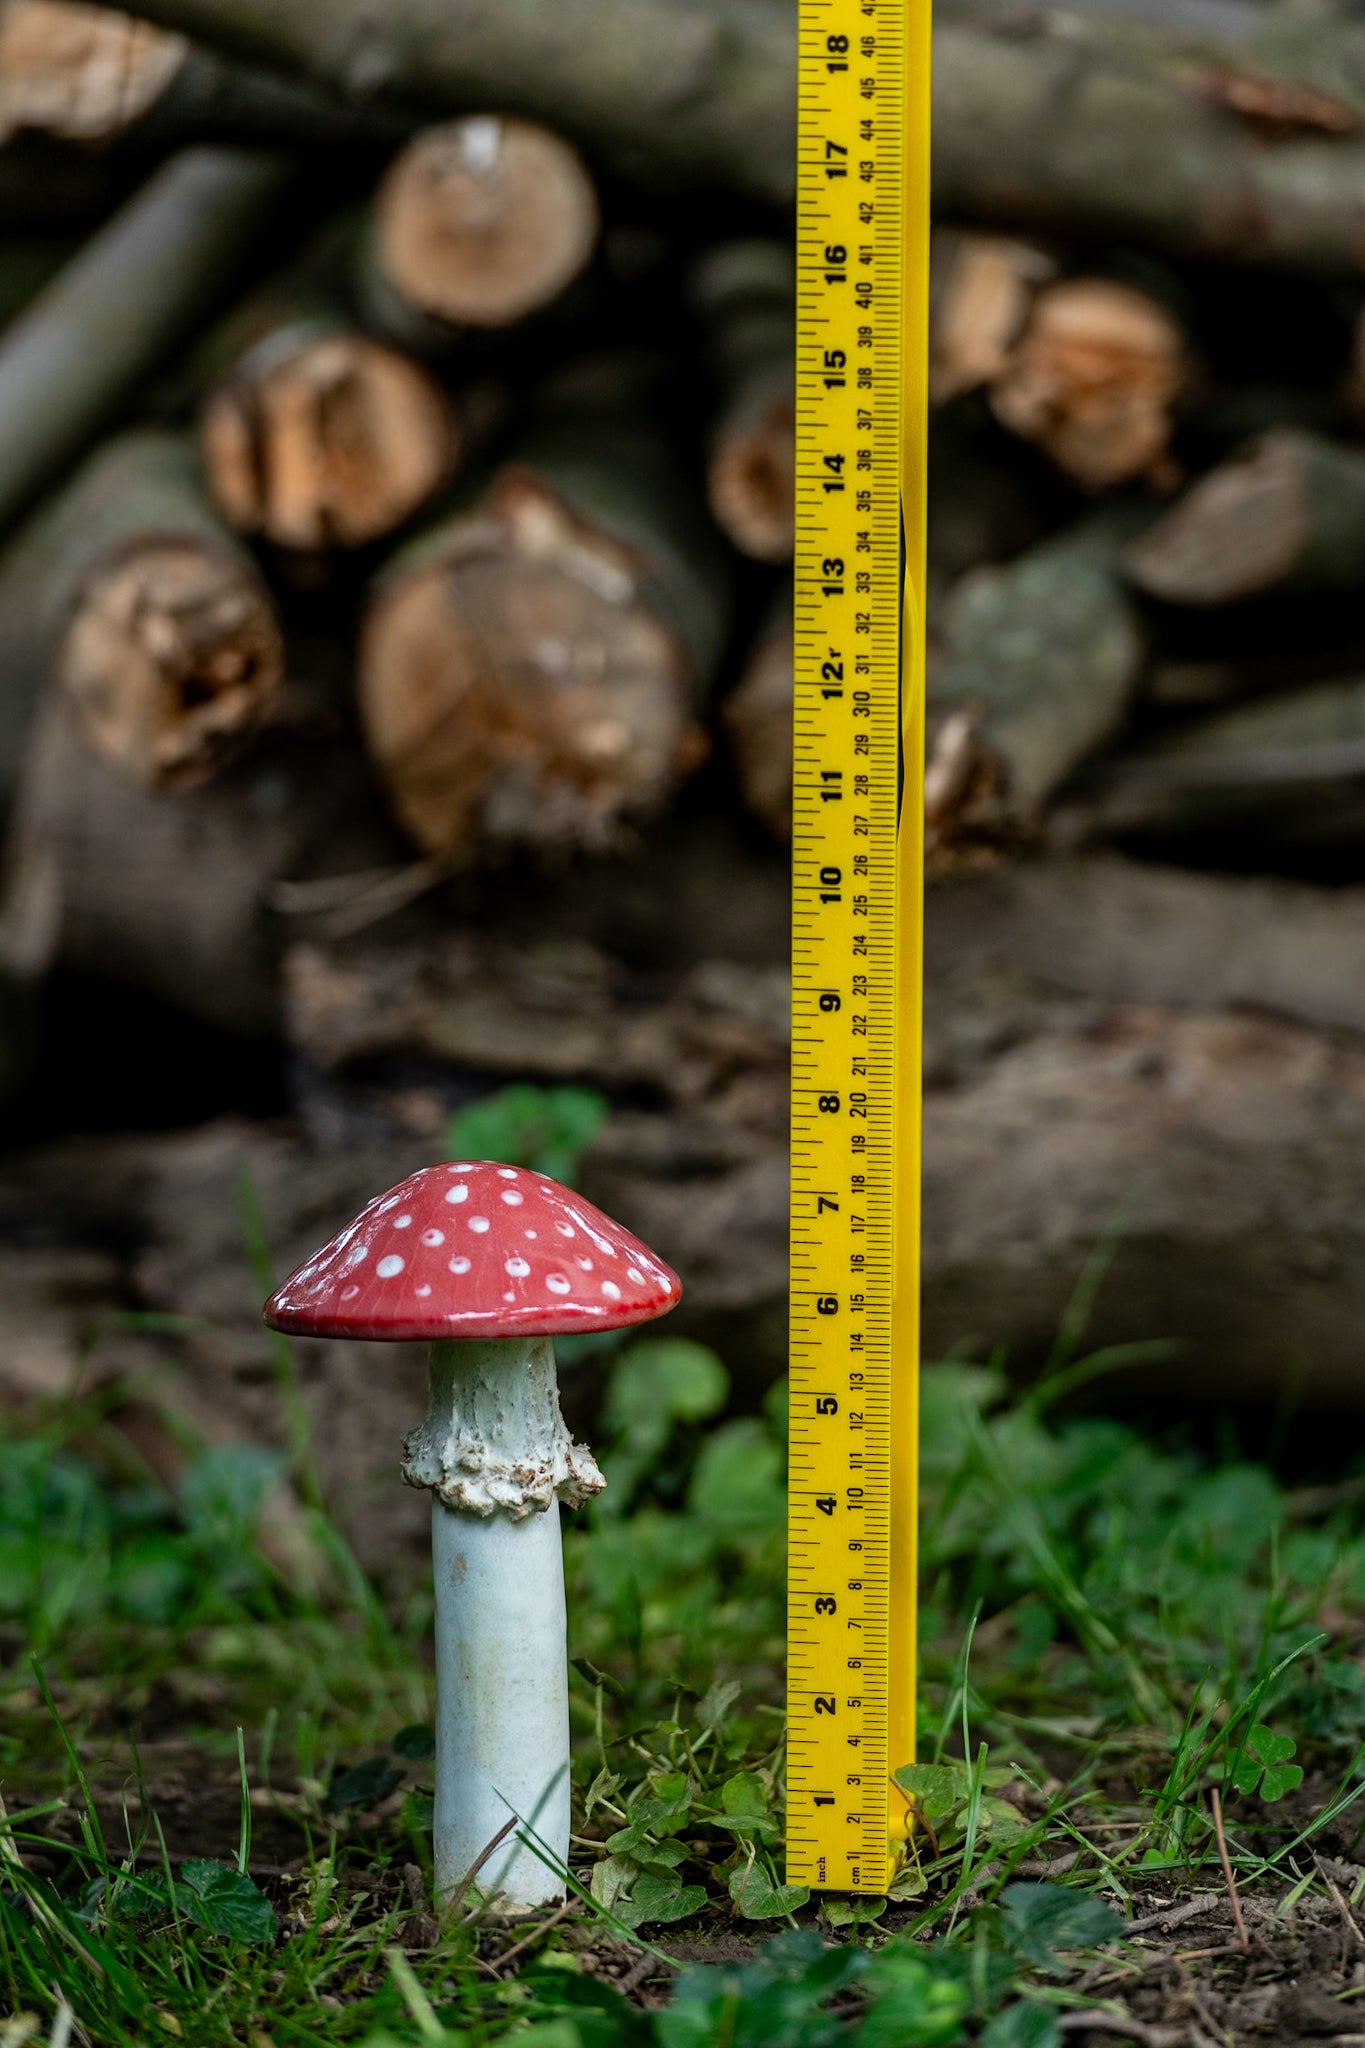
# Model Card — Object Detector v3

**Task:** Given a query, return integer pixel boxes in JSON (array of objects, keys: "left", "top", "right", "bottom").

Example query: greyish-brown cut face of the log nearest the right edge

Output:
[{"left": 1124, "top": 430, "right": 1312, "bottom": 606}]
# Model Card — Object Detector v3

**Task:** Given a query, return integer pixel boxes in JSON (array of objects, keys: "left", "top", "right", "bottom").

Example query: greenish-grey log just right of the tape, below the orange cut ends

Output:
[{"left": 925, "top": 506, "right": 1144, "bottom": 856}]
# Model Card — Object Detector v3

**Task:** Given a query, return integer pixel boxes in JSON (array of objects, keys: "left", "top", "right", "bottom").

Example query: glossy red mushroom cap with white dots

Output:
[{"left": 264, "top": 1159, "right": 681, "bottom": 1343}]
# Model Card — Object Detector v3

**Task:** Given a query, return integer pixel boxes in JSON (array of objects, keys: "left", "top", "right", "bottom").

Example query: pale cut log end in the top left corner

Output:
[{"left": 0, "top": 0, "right": 188, "bottom": 141}]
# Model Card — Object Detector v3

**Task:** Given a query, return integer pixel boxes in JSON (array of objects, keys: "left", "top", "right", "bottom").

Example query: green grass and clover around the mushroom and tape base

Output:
[{"left": 0, "top": 1261, "right": 1365, "bottom": 2048}]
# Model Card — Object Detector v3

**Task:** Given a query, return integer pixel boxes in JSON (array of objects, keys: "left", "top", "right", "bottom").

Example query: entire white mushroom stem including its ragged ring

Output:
[{"left": 403, "top": 1337, "right": 604, "bottom": 1915}]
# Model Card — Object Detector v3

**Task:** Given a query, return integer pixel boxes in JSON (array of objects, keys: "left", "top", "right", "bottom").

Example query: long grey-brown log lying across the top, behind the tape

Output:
[{"left": 109, "top": 0, "right": 1365, "bottom": 276}]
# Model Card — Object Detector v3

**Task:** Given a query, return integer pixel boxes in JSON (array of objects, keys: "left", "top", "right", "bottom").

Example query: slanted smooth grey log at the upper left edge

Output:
[{"left": 0, "top": 150, "right": 289, "bottom": 526}]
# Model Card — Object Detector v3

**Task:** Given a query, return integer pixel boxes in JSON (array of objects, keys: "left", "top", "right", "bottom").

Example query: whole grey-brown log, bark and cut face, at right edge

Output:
[{"left": 1126, "top": 426, "right": 1365, "bottom": 606}]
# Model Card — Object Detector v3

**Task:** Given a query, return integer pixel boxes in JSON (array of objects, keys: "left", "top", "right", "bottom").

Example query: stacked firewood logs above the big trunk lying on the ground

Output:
[{"left": 0, "top": 0, "right": 1365, "bottom": 1073}]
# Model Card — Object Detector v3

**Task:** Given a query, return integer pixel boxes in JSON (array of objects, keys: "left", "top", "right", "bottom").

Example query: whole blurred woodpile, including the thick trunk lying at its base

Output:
[{"left": 10, "top": 0, "right": 1365, "bottom": 1427}]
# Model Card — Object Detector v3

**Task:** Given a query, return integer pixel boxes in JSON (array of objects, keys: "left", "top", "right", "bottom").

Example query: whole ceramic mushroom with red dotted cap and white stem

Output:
[{"left": 266, "top": 1161, "right": 681, "bottom": 1915}]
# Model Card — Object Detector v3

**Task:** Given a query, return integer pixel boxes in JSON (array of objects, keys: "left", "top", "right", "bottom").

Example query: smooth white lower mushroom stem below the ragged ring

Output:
[{"left": 432, "top": 1497, "right": 569, "bottom": 1917}]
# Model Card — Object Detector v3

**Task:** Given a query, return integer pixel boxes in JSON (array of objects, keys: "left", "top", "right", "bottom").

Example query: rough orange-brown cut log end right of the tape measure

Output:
[{"left": 990, "top": 276, "right": 1185, "bottom": 489}]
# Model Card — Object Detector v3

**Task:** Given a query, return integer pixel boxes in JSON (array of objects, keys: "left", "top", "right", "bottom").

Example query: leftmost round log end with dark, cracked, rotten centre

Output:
[{"left": 57, "top": 541, "right": 284, "bottom": 788}]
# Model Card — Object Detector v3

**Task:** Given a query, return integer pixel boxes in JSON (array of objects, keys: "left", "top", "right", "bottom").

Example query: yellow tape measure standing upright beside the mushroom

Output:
[{"left": 786, "top": 0, "right": 929, "bottom": 1892}]
